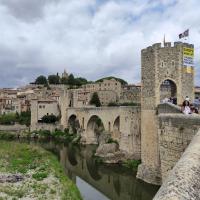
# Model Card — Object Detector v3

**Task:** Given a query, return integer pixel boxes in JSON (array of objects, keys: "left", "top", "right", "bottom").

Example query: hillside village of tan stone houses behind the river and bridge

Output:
[{"left": 0, "top": 71, "right": 141, "bottom": 123}]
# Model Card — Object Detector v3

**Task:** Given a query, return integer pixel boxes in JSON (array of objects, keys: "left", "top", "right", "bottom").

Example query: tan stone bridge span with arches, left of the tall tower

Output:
[{"left": 66, "top": 106, "right": 141, "bottom": 157}]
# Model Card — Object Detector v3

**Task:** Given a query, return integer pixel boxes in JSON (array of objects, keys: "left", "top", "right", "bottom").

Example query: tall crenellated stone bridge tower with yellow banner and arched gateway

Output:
[{"left": 137, "top": 42, "right": 194, "bottom": 184}]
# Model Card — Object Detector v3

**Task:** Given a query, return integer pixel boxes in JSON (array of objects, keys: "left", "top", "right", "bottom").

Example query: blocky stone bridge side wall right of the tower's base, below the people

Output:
[{"left": 158, "top": 114, "right": 200, "bottom": 182}]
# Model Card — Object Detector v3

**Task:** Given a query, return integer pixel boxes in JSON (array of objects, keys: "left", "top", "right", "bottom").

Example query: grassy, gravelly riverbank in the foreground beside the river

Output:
[{"left": 0, "top": 141, "right": 82, "bottom": 200}]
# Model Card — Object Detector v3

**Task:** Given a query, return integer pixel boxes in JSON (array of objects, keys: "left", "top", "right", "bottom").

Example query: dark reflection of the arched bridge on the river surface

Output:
[{"left": 60, "top": 144, "right": 157, "bottom": 200}]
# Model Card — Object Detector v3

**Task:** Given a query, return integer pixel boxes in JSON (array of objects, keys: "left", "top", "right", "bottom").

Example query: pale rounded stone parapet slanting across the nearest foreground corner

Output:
[{"left": 154, "top": 129, "right": 200, "bottom": 200}]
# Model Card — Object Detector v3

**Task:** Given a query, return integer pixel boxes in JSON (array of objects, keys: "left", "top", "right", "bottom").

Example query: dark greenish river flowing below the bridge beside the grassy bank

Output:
[{"left": 28, "top": 141, "right": 159, "bottom": 200}]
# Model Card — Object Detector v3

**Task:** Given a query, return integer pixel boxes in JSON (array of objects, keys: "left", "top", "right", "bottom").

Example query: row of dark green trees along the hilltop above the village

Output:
[{"left": 35, "top": 73, "right": 88, "bottom": 86}]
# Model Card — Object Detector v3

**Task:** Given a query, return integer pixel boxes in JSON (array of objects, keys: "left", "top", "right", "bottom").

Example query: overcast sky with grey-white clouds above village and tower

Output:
[{"left": 0, "top": 0, "right": 200, "bottom": 87}]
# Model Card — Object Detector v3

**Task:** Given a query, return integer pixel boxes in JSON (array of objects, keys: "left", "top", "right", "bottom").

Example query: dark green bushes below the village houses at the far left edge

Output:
[{"left": 0, "top": 111, "right": 31, "bottom": 126}]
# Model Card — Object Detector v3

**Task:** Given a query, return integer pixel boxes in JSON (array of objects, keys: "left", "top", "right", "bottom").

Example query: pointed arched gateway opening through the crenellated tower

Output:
[{"left": 160, "top": 79, "right": 177, "bottom": 101}]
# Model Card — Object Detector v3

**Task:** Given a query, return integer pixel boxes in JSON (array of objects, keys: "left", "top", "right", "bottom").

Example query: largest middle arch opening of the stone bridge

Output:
[{"left": 86, "top": 115, "right": 105, "bottom": 143}]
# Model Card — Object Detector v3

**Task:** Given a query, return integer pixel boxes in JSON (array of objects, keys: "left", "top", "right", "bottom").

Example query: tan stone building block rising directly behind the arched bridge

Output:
[{"left": 69, "top": 79, "right": 141, "bottom": 107}]
